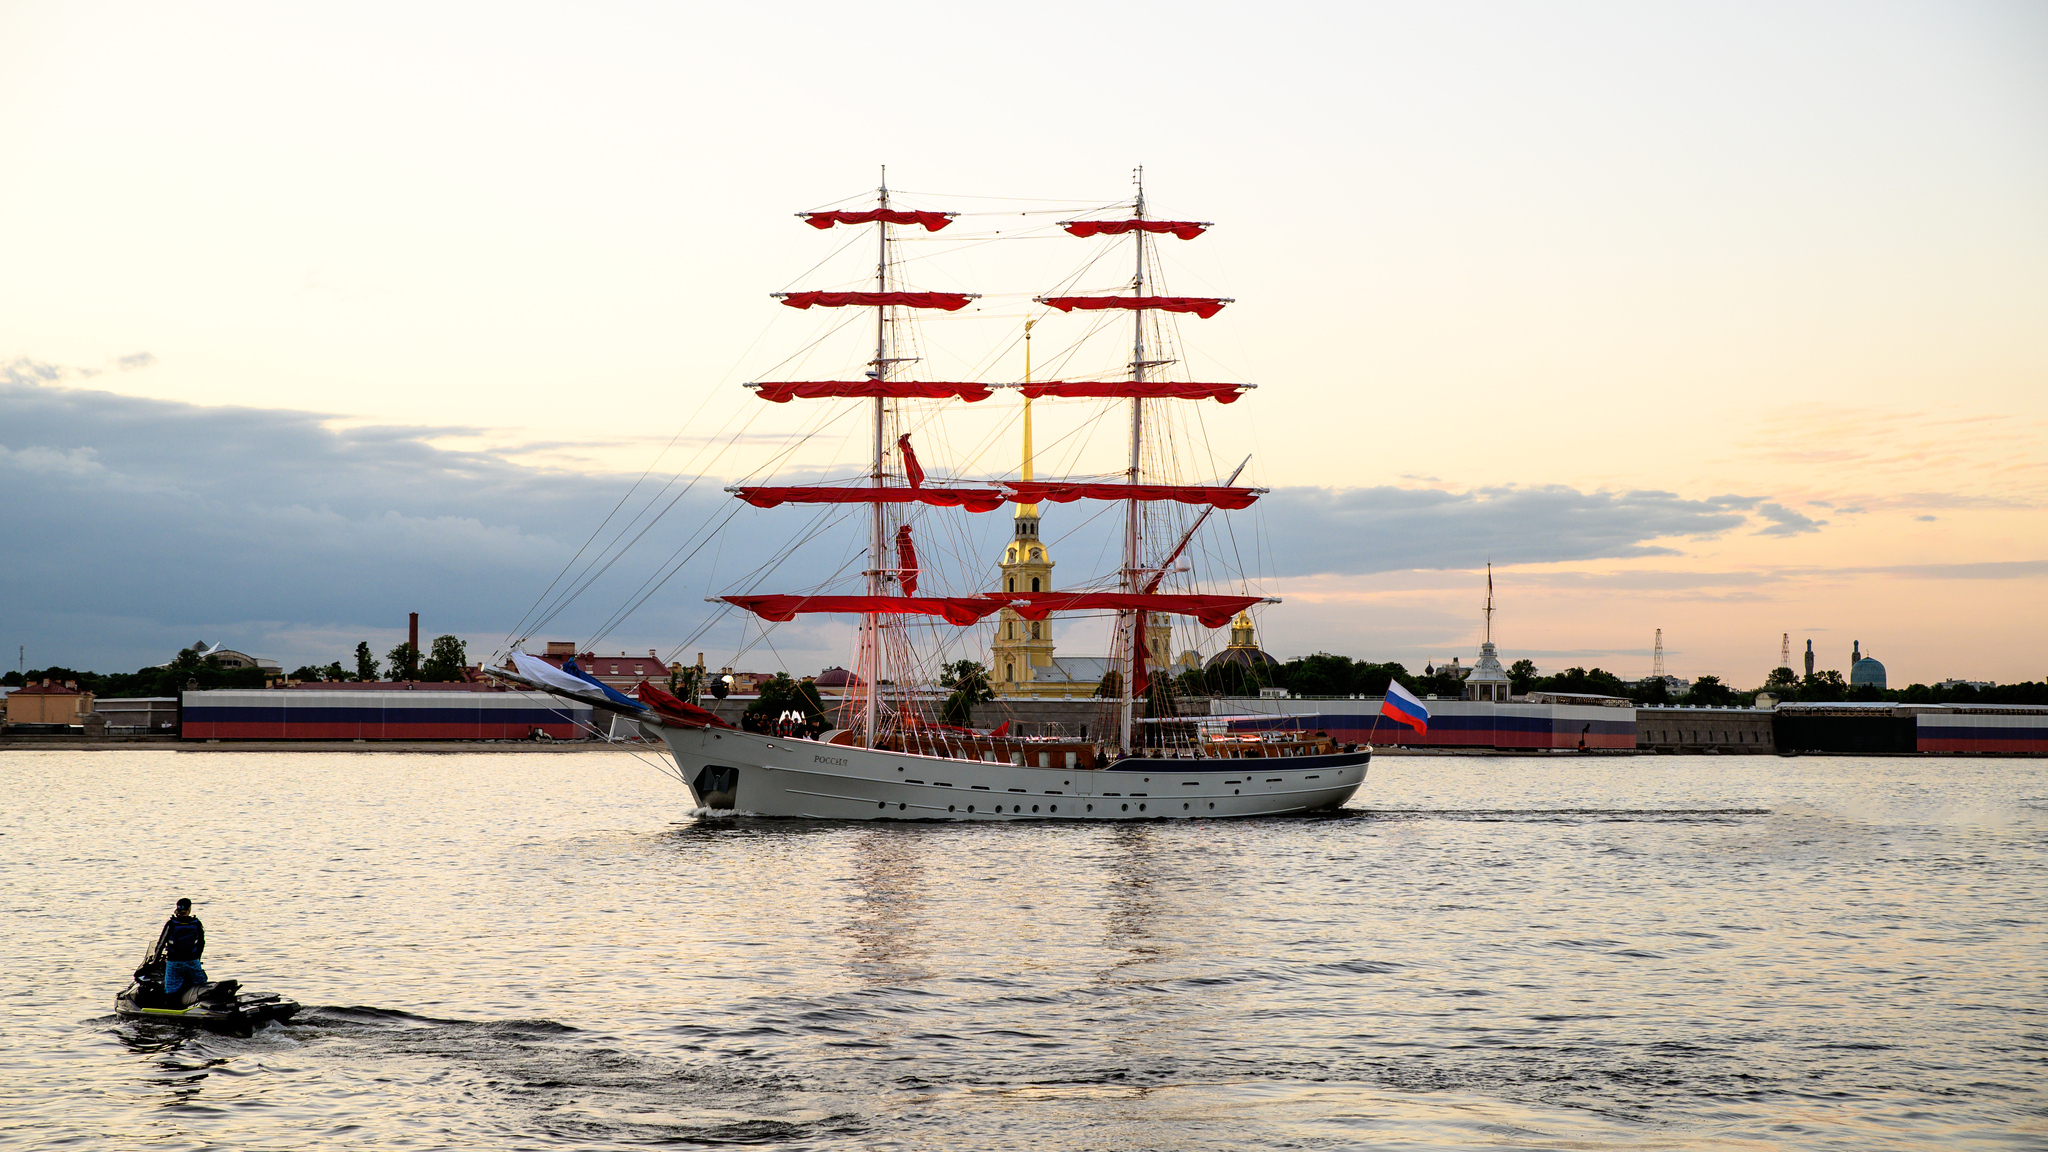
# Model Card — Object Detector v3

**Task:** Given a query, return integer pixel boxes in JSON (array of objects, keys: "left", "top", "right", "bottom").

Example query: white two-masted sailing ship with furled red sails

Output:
[{"left": 508, "top": 170, "right": 1370, "bottom": 820}]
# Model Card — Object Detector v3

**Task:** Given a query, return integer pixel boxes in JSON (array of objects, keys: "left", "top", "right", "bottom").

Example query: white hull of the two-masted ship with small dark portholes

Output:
[{"left": 641, "top": 724, "right": 1372, "bottom": 820}]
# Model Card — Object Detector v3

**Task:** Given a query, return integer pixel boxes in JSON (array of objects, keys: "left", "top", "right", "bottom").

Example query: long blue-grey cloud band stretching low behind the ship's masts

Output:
[{"left": 0, "top": 359, "right": 1875, "bottom": 668}]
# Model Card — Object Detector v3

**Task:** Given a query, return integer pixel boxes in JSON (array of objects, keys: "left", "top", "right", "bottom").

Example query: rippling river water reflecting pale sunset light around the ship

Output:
[{"left": 0, "top": 750, "right": 2048, "bottom": 1150}]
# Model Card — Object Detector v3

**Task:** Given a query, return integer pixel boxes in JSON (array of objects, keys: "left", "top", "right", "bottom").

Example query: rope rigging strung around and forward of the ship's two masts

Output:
[{"left": 506, "top": 189, "right": 1264, "bottom": 709}]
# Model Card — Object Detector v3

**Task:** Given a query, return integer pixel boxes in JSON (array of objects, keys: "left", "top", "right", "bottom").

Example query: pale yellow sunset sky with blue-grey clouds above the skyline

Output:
[{"left": 0, "top": 2, "right": 2048, "bottom": 687}]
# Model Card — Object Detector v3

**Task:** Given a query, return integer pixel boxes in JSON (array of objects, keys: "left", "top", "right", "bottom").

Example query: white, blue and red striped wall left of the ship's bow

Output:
[{"left": 182, "top": 689, "right": 592, "bottom": 740}]
